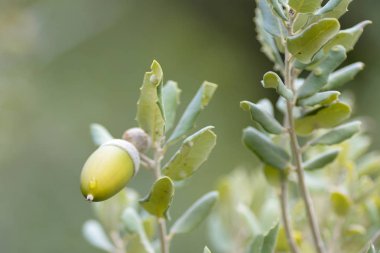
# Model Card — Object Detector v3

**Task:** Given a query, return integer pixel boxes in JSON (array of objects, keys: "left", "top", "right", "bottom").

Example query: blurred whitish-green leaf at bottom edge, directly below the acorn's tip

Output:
[{"left": 82, "top": 220, "right": 114, "bottom": 252}]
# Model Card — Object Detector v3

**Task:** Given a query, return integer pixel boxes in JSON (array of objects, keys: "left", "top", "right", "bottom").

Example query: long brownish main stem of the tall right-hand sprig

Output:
[{"left": 285, "top": 18, "right": 326, "bottom": 253}]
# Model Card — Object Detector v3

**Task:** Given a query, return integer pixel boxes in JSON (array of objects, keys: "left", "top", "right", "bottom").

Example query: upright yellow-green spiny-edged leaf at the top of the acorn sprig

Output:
[{"left": 136, "top": 61, "right": 165, "bottom": 142}]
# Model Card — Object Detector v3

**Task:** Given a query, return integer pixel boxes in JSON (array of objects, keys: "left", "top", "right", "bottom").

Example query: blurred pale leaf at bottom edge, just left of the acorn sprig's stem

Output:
[{"left": 122, "top": 207, "right": 154, "bottom": 253}]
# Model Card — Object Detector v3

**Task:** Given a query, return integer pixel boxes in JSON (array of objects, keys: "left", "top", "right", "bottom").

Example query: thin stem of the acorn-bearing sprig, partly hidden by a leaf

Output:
[{"left": 153, "top": 142, "right": 169, "bottom": 253}]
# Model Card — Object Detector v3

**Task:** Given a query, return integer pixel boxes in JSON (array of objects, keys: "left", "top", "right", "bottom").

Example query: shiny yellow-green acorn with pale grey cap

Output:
[{"left": 80, "top": 139, "right": 140, "bottom": 202}]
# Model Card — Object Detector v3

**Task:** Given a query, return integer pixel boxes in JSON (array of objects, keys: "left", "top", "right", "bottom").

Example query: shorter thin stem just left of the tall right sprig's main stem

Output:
[{"left": 279, "top": 179, "right": 299, "bottom": 253}]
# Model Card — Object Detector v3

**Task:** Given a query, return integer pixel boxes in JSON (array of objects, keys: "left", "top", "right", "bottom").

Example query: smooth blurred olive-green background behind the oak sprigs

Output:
[{"left": 0, "top": 0, "right": 380, "bottom": 253}]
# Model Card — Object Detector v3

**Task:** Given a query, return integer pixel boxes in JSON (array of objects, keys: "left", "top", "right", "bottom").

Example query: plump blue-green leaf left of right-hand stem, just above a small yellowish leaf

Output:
[{"left": 243, "top": 127, "right": 290, "bottom": 169}]
